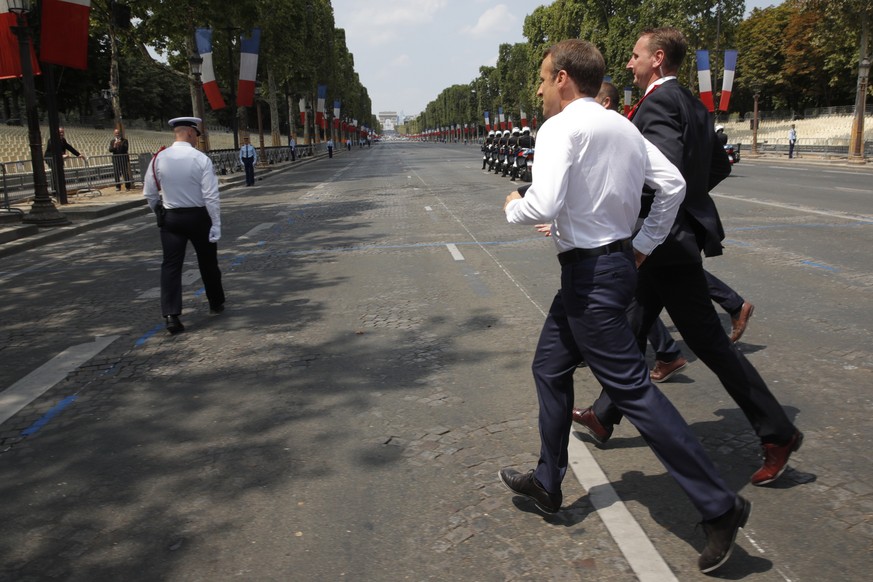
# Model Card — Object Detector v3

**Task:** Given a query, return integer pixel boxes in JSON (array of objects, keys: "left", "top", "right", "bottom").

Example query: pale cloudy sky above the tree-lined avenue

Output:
[{"left": 331, "top": 0, "right": 782, "bottom": 115}]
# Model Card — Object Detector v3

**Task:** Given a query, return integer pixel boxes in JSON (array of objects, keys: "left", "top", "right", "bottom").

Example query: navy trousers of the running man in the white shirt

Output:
[{"left": 532, "top": 251, "right": 736, "bottom": 520}]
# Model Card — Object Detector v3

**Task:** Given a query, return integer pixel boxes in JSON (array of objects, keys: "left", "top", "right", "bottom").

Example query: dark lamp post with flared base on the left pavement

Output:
[{"left": 7, "top": 0, "right": 70, "bottom": 226}]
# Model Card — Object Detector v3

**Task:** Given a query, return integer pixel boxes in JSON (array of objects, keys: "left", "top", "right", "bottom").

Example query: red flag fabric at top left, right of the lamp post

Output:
[{"left": 39, "top": 0, "right": 91, "bottom": 70}]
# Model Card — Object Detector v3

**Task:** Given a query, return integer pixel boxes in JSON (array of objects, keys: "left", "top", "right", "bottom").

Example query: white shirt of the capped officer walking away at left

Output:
[{"left": 143, "top": 141, "right": 221, "bottom": 226}]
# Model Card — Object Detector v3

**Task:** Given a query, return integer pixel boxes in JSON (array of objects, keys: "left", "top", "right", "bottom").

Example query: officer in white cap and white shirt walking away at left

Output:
[{"left": 143, "top": 117, "right": 224, "bottom": 334}]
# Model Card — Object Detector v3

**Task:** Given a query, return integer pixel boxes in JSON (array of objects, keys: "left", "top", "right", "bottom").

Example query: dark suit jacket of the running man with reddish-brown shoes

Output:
[{"left": 632, "top": 79, "right": 731, "bottom": 266}]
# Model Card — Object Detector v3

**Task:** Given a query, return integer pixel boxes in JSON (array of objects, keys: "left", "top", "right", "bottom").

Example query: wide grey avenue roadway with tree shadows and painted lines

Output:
[{"left": 0, "top": 144, "right": 873, "bottom": 581}]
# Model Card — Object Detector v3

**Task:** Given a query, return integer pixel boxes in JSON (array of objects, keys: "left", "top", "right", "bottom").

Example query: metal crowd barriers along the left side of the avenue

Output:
[{"left": 0, "top": 144, "right": 326, "bottom": 210}]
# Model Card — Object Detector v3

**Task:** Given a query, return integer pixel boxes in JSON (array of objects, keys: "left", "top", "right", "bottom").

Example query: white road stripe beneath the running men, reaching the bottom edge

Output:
[{"left": 568, "top": 436, "right": 678, "bottom": 582}]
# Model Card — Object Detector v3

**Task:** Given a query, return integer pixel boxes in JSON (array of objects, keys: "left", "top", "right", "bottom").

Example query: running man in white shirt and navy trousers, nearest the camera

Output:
[{"left": 498, "top": 39, "right": 751, "bottom": 572}]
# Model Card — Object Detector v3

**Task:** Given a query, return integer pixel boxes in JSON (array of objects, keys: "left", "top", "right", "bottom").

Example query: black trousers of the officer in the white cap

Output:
[{"left": 161, "top": 207, "right": 224, "bottom": 317}]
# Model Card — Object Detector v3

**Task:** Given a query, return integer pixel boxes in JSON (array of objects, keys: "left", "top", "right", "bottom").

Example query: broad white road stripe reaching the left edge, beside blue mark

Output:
[{"left": 0, "top": 335, "right": 121, "bottom": 424}]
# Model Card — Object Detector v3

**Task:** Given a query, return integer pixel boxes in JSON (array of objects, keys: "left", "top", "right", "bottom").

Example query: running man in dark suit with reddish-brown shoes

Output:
[{"left": 576, "top": 28, "right": 803, "bottom": 485}]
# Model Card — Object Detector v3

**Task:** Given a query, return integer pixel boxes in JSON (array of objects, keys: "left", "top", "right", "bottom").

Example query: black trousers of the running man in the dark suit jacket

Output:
[{"left": 593, "top": 263, "right": 797, "bottom": 445}]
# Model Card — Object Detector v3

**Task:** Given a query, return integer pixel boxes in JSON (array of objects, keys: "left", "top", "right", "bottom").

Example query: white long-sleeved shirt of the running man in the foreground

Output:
[{"left": 506, "top": 97, "right": 685, "bottom": 255}]
